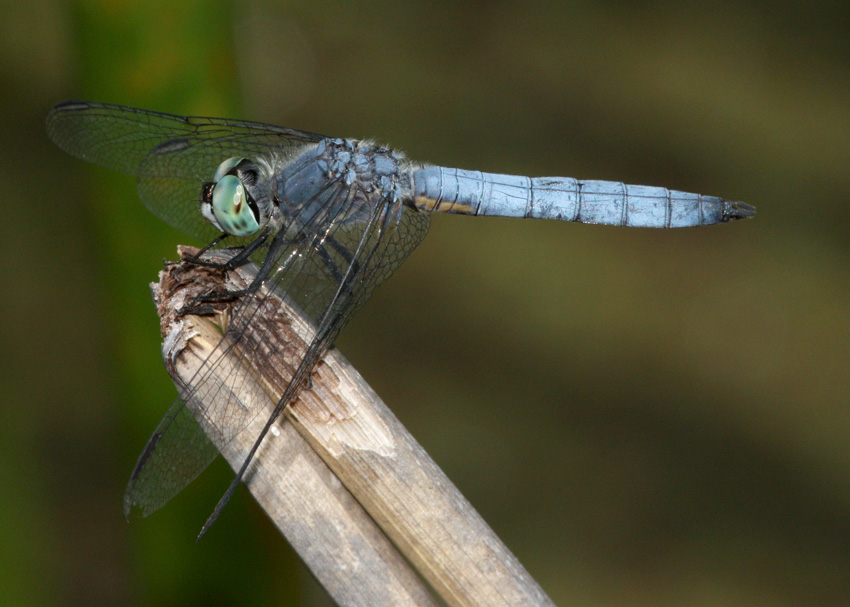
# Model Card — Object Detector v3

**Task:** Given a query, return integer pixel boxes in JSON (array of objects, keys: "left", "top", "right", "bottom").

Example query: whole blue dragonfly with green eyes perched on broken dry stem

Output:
[{"left": 46, "top": 101, "right": 755, "bottom": 538}]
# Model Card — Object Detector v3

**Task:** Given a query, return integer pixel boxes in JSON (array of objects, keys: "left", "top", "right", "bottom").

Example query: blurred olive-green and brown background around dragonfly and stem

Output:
[{"left": 0, "top": 0, "right": 850, "bottom": 607}]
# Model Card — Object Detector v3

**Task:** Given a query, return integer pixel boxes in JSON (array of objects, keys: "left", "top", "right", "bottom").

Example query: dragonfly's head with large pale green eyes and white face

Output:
[{"left": 201, "top": 158, "right": 261, "bottom": 236}]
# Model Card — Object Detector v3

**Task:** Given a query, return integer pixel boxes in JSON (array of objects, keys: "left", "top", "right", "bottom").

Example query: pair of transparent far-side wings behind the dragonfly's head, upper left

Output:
[{"left": 46, "top": 101, "right": 324, "bottom": 242}]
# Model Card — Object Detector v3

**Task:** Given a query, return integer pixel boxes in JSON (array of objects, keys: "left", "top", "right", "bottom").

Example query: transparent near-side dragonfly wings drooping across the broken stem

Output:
[{"left": 124, "top": 181, "right": 429, "bottom": 516}]
